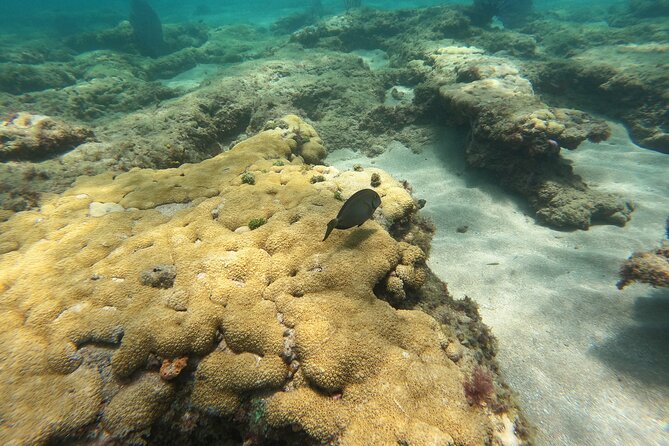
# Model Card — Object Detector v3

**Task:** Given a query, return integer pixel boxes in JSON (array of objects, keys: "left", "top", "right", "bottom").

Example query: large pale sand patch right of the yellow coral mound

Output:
[{"left": 327, "top": 120, "right": 669, "bottom": 446}]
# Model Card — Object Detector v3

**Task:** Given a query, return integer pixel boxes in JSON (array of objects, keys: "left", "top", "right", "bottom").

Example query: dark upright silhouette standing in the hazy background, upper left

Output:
[{"left": 130, "top": 0, "right": 166, "bottom": 58}]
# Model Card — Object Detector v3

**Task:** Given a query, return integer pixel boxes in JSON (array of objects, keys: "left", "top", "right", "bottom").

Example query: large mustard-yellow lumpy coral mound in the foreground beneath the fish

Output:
[{"left": 0, "top": 116, "right": 522, "bottom": 445}]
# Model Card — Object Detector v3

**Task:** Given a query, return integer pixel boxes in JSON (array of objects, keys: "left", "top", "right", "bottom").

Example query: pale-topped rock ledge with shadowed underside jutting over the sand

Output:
[{"left": 432, "top": 46, "right": 634, "bottom": 229}]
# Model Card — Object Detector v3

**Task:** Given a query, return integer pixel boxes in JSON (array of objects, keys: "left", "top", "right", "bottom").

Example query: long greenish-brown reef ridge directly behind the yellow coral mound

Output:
[{"left": 0, "top": 49, "right": 408, "bottom": 210}]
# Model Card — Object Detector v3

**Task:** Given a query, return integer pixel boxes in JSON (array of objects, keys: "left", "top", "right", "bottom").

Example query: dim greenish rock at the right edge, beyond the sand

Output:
[{"left": 534, "top": 44, "right": 669, "bottom": 153}]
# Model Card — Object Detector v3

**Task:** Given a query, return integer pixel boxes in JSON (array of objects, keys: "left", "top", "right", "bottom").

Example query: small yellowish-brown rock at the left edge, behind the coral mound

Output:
[{"left": 0, "top": 112, "right": 94, "bottom": 161}]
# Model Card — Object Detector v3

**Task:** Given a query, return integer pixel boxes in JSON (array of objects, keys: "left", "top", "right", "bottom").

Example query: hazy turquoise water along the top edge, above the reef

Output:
[{"left": 0, "top": 0, "right": 627, "bottom": 34}]
